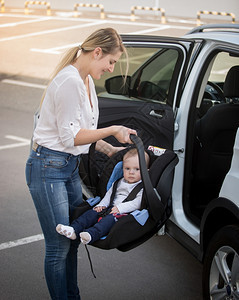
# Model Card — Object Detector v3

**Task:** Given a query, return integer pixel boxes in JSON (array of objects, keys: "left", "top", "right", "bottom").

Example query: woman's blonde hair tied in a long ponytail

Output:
[{"left": 41, "top": 28, "right": 129, "bottom": 104}]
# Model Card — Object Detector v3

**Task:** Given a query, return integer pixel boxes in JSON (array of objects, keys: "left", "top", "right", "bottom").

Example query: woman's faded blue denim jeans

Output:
[{"left": 26, "top": 146, "right": 82, "bottom": 300}]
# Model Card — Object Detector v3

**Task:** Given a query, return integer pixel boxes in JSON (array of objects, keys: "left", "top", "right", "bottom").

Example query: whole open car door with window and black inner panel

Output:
[{"left": 95, "top": 36, "right": 193, "bottom": 150}]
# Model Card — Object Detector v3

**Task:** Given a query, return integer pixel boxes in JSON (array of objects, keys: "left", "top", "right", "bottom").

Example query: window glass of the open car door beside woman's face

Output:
[{"left": 96, "top": 47, "right": 179, "bottom": 103}]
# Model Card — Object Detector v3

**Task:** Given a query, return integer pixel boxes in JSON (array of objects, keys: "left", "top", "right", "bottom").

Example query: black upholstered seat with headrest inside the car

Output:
[{"left": 192, "top": 66, "right": 239, "bottom": 213}]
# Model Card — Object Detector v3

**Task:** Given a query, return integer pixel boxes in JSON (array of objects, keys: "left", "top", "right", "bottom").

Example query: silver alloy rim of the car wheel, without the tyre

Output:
[{"left": 209, "top": 246, "right": 239, "bottom": 300}]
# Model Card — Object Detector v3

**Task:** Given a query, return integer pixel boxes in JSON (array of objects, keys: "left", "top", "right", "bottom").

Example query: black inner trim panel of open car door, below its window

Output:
[{"left": 99, "top": 98, "right": 174, "bottom": 149}]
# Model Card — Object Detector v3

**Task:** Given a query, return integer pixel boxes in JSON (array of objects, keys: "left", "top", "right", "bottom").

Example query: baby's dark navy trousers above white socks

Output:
[{"left": 71, "top": 209, "right": 115, "bottom": 244}]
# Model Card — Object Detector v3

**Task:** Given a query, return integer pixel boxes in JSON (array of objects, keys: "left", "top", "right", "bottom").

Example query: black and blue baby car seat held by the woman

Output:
[{"left": 71, "top": 135, "right": 178, "bottom": 251}]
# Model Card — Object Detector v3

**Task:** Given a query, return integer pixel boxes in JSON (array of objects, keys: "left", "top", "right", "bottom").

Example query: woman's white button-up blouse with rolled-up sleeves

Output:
[{"left": 33, "top": 65, "right": 99, "bottom": 155}]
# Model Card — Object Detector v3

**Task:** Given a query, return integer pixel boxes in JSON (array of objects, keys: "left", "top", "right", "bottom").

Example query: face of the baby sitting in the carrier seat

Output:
[{"left": 123, "top": 156, "right": 141, "bottom": 183}]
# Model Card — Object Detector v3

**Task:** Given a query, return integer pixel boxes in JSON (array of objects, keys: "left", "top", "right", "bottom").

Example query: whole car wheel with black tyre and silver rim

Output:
[{"left": 203, "top": 225, "right": 239, "bottom": 300}]
